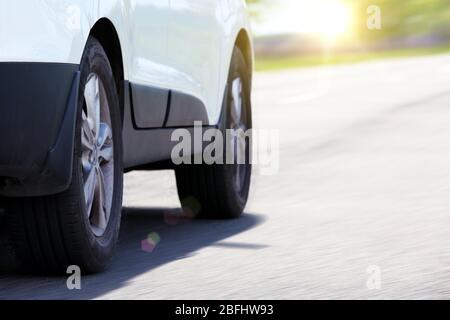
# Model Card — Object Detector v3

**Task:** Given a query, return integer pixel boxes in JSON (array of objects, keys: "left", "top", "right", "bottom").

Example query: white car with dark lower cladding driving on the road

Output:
[{"left": 0, "top": 0, "right": 253, "bottom": 273}]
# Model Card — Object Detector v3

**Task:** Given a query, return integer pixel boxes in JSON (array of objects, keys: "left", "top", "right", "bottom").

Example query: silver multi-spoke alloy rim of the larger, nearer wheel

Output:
[{"left": 81, "top": 73, "right": 114, "bottom": 237}]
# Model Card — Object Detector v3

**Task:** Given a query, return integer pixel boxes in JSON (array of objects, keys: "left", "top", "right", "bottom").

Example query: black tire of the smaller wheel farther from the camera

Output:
[{"left": 175, "top": 47, "right": 252, "bottom": 219}]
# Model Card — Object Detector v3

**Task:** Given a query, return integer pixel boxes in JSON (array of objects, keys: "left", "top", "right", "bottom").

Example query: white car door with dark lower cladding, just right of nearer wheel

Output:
[{"left": 127, "top": 0, "right": 170, "bottom": 129}]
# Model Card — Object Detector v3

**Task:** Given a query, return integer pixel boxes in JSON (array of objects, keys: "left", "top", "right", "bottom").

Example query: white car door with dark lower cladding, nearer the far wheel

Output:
[{"left": 168, "top": 0, "right": 222, "bottom": 126}]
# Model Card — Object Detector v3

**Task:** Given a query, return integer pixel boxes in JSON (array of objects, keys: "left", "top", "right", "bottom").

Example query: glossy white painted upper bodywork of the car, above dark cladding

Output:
[{"left": 0, "top": 0, "right": 250, "bottom": 123}]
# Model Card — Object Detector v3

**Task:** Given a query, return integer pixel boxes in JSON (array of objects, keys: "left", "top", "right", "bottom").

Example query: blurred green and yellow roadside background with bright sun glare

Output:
[{"left": 247, "top": 0, "right": 450, "bottom": 70}]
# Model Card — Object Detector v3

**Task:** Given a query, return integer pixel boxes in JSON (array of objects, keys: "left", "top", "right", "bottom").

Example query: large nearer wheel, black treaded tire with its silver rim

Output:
[{"left": 6, "top": 37, "right": 123, "bottom": 274}]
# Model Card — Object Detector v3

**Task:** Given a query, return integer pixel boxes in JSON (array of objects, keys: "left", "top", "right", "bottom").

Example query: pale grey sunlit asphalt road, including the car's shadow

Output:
[{"left": 0, "top": 55, "right": 450, "bottom": 299}]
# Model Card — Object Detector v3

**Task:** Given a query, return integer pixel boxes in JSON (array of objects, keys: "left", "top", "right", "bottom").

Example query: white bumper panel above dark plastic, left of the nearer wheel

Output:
[{"left": 0, "top": 0, "right": 96, "bottom": 64}]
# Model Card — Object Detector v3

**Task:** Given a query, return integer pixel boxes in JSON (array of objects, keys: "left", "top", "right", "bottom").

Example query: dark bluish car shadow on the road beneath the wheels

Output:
[{"left": 0, "top": 208, "right": 265, "bottom": 299}]
